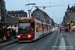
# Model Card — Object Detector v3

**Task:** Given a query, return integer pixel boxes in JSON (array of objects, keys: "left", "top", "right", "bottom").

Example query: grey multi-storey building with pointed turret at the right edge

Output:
[{"left": 65, "top": 5, "right": 75, "bottom": 25}]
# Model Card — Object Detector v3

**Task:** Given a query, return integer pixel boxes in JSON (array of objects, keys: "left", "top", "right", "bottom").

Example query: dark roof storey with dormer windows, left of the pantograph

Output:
[{"left": 7, "top": 10, "right": 27, "bottom": 19}]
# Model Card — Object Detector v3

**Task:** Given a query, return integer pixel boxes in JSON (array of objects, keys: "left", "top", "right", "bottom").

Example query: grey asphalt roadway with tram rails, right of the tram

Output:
[{"left": 1, "top": 30, "right": 60, "bottom": 50}]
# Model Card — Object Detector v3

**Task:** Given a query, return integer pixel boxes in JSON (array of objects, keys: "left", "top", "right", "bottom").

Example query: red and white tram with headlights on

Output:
[{"left": 18, "top": 17, "right": 50, "bottom": 42}]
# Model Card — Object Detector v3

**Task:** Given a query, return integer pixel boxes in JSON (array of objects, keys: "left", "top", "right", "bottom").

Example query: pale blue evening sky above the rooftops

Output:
[{"left": 4, "top": 0, "right": 75, "bottom": 24}]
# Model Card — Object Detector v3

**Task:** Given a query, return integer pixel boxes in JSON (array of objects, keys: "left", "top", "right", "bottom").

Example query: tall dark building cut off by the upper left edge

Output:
[{"left": 0, "top": 0, "right": 6, "bottom": 22}]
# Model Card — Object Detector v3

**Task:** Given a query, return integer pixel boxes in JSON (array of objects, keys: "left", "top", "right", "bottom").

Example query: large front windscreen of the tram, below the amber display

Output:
[{"left": 19, "top": 23, "right": 30, "bottom": 34}]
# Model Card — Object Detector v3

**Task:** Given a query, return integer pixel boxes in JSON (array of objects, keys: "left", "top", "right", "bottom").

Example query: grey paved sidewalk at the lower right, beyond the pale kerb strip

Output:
[{"left": 62, "top": 32, "right": 75, "bottom": 50}]
